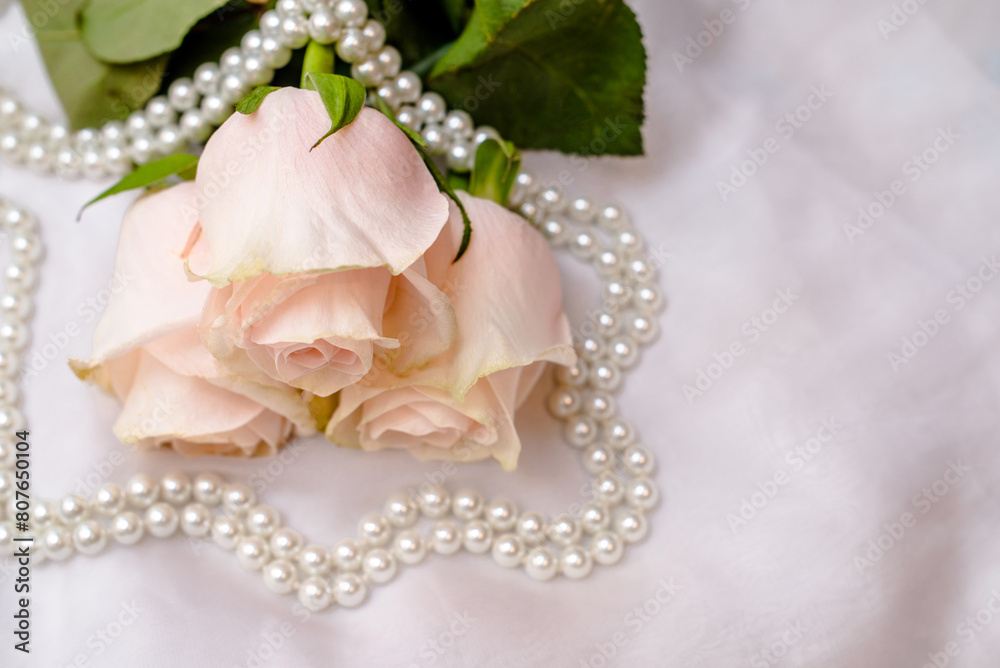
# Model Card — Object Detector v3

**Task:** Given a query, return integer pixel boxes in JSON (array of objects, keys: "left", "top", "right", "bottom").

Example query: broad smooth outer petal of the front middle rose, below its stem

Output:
[{"left": 191, "top": 88, "right": 448, "bottom": 285}]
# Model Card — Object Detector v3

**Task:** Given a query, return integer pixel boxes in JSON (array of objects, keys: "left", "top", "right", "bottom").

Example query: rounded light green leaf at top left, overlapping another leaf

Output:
[{"left": 80, "top": 0, "right": 228, "bottom": 63}]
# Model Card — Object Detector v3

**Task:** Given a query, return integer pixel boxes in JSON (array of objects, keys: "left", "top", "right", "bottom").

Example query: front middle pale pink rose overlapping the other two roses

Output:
[{"left": 189, "top": 88, "right": 455, "bottom": 396}]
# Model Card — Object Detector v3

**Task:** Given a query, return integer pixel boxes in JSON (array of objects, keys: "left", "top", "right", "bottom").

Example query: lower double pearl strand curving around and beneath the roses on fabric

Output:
[{"left": 0, "top": 183, "right": 662, "bottom": 611}]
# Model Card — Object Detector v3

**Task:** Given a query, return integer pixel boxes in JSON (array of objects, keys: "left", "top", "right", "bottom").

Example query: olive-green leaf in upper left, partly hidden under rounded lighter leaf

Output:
[{"left": 20, "top": 0, "right": 167, "bottom": 129}]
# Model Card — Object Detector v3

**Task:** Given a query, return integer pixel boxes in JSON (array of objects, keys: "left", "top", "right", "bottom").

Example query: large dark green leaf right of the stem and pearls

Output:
[{"left": 427, "top": 0, "right": 646, "bottom": 155}]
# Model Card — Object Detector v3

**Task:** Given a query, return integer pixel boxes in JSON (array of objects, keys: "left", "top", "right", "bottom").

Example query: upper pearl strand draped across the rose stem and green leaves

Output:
[{"left": 0, "top": 0, "right": 496, "bottom": 180}]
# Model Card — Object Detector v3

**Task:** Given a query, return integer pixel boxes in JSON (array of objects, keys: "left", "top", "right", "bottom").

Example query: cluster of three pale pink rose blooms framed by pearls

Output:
[{"left": 73, "top": 89, "right": 574, "bottom": 468}]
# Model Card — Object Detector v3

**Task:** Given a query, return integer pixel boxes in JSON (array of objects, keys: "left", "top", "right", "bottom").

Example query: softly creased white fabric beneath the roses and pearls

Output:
[{"left": 0, "top": 0, "right": 1000, "bottom": 668}]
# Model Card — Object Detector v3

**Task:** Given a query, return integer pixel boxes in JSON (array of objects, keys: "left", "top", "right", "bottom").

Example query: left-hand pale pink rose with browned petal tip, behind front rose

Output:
[{"left": 71, "top": 183, "right": 315, "bottom": 455}]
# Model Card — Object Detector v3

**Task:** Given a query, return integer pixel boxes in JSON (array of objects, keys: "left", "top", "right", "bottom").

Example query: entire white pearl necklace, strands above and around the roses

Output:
[{"left": 0, "top": 0, "right": 663, "bottom": 611}]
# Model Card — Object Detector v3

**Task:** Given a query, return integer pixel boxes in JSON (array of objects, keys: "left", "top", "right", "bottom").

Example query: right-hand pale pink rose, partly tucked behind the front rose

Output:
[{"left": 326, "top": 193, "right": 576, "bottom": 470}]
